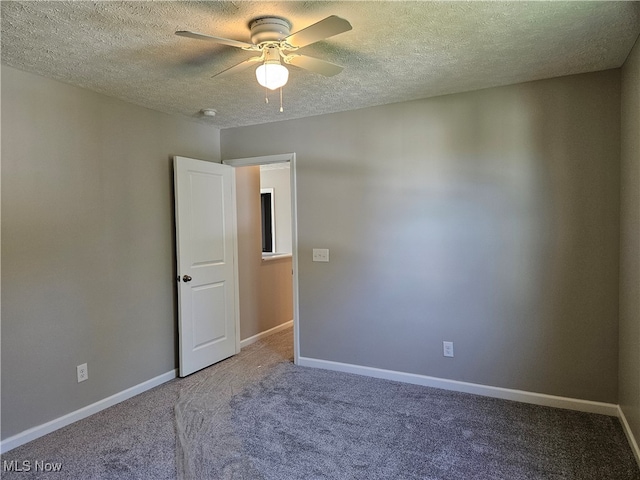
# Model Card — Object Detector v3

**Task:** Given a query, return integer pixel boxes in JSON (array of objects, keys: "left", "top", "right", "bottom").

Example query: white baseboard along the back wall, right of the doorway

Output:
[{"left": 298, "top": 357, "right": 619, "bottom": 417}]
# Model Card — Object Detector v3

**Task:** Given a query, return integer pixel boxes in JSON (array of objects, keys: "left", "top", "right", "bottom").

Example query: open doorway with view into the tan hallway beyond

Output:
[{"left": 222, "top": 153, "right": 299, "bottom": 364}]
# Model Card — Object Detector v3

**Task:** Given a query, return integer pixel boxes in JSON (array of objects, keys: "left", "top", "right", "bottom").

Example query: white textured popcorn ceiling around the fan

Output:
[{"left": 0, "top": 1, "right": 640, "bottom": 128}]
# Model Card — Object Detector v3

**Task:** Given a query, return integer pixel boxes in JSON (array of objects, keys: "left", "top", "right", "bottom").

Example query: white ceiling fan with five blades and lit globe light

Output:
[{"left": 176, "top": 15, "right": 352, "bottom": 90}]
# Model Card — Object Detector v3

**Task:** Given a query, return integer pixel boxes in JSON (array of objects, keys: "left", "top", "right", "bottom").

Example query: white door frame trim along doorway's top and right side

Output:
[{"left": 222, "top": 153, "right": 300, "bottom": 365}]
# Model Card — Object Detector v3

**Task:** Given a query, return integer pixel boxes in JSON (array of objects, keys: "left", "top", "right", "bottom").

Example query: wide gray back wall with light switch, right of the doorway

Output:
[{"left": 221, "top": 70, "right": 621, "bottom": 403}]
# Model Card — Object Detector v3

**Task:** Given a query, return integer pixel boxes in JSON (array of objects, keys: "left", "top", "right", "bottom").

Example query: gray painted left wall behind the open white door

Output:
[{"left": 2, "top": 66, "right": 220, "bottom": 438}]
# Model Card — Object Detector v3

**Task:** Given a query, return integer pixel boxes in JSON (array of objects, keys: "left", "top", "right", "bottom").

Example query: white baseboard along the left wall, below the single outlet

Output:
[{"left": 0, "top": 370, "right": 178, "bottom": 453}]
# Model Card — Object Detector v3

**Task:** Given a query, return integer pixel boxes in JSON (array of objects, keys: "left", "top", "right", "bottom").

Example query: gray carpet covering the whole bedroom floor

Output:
[{"left": 2, "top": 324, "right": 640, "bottom": 480}]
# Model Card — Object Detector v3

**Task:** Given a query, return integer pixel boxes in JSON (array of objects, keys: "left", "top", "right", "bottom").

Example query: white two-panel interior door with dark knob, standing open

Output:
[{"left": 174, "top": 157, "right": 240, "bottom": 377}]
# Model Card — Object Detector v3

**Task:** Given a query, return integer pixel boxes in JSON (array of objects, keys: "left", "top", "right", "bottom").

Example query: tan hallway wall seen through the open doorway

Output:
[{"left": 236, "top": 166, "right": 293, "bottom": 340}]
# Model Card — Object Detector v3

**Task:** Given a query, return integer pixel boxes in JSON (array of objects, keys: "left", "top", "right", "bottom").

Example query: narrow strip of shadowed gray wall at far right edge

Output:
[{"left": 619, "top": 34, "right": 640, "bottom": 450}]
